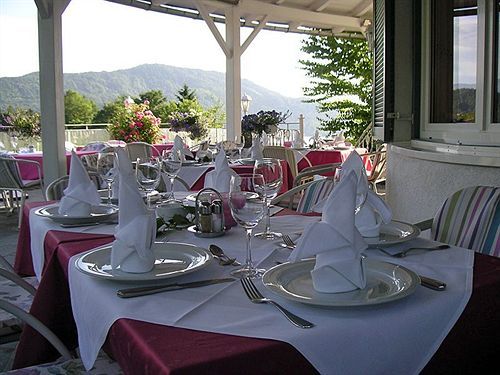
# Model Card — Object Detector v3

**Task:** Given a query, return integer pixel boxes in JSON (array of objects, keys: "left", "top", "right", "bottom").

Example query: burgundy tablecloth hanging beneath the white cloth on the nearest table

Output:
[{"left": 10, "top": 204, "right": 500, "bottom": 374}]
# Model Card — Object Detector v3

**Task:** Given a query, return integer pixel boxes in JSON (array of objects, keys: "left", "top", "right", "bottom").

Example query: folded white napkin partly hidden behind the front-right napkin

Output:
[{"left": 342, "top": 151, "right": 392, "bottom": 237}]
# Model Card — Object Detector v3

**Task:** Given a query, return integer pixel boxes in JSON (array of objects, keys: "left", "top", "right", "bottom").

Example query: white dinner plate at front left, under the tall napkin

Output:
[{"left": 75, "top": 242, "right": 212, "bottom": 282}]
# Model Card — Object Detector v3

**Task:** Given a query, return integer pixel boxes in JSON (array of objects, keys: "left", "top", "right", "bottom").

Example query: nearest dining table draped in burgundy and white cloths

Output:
[{"left": 14, "top": 202, "right": 500, "bottom": 374}]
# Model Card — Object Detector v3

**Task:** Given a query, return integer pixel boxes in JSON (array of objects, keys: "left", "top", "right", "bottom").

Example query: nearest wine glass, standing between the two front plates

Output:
[{"left": 229, "top": 174, "right": 266, "bottom": 278}]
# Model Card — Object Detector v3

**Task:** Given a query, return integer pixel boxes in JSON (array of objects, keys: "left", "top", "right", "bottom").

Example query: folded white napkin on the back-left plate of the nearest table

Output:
[{"left": 59, "top": 151, "right": 101, "bottom": 216}]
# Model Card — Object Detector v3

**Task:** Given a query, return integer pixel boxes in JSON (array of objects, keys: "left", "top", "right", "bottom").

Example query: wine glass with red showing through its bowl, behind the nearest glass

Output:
[{"left": 253, "top": 158, "right": 283, "bottom": 240}]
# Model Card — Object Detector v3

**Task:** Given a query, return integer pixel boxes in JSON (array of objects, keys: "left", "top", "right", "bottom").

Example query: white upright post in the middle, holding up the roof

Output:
[{"left": 226, "top": 6, "right": 241, "bottom": 139}]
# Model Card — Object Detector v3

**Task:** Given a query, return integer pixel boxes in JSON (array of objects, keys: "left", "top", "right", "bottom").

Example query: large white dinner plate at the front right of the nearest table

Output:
[{"left": 262, "top": 258, "right": 420, "bottom": 307}]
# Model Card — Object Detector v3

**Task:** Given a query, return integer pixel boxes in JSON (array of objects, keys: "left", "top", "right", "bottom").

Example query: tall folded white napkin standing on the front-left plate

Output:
[{"left": 111, "top": 148, "right": 156, "bottom": 273}]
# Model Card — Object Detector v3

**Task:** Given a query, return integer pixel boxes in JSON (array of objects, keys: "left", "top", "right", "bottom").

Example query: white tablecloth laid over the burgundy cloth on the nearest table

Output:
[{"left": 69, "top": 216, "right": 473, "bottom": 374}]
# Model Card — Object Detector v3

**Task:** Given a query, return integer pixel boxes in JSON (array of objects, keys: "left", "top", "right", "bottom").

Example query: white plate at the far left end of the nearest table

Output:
[{"left": 35, "top": 204, "right": 118, "bottom": 224}]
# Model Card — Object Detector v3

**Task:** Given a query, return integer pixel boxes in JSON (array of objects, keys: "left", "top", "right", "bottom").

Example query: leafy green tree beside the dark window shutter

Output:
[{"left": 300, "top": 36, "right": 373, "bottom": 141}]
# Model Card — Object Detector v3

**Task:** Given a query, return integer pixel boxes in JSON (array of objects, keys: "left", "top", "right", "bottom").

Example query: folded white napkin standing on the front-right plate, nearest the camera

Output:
[{"left": 289, "top": 172, "right": 368, "bottom": 293}]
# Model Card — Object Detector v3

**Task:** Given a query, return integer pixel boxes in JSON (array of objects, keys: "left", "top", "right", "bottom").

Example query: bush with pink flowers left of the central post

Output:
[{"left": 108, "top": 98, "right": 161, "bottom": 144}]
